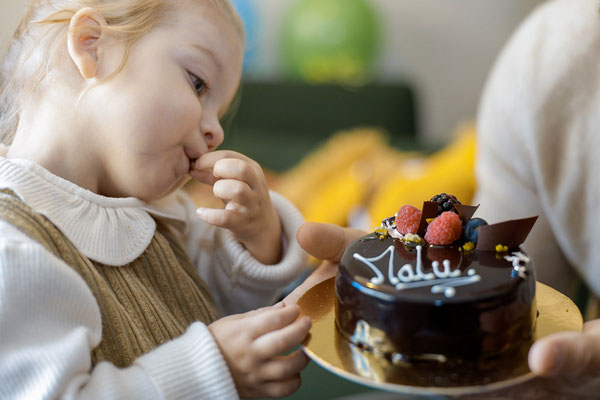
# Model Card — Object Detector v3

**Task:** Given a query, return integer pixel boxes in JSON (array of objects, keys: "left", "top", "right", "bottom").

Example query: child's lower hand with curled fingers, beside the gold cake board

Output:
[{"left": 208, "top": 303, "right": 311, "bottom": 397}]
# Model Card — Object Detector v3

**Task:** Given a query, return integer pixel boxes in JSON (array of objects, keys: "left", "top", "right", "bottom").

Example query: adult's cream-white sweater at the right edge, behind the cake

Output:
[{"left": 476, "top": 0, "right": 600, "bottom": 295}]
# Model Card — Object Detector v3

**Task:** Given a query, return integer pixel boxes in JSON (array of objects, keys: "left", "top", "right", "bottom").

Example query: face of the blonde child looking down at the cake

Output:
[{"left": 85, "top": 2, "right": 243, "bottom": 200}]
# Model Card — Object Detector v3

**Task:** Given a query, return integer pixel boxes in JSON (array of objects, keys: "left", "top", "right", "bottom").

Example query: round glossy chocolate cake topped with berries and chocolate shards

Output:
[{"left": 335, "top": 195, "right": 536, "bottom": 363}]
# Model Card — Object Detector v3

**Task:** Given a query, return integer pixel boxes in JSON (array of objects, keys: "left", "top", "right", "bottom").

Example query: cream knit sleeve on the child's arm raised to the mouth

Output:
[{"left": 151, "top": 191, "right": 308, "bottom": 314}]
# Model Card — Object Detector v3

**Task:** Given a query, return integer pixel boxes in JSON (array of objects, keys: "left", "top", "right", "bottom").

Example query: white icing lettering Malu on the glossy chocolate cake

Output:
[{"left": 352, "top": 246, "right": 481, "bottom": 298}]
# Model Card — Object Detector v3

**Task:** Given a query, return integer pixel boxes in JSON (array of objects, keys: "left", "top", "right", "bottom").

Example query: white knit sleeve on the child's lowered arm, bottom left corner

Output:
[{"left": 0, "top": 222, "right": 237, "bottom": 399}]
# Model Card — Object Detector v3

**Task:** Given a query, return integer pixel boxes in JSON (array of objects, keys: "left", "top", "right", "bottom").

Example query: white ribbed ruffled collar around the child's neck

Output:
[{"left": 0, "top": 157, "right": 156, "bottom": 266}]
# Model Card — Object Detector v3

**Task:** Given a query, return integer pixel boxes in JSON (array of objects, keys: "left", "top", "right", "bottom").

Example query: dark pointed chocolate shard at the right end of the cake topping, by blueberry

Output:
[{"left": 475, "top": 216, "right": 537, "bottom": 251}]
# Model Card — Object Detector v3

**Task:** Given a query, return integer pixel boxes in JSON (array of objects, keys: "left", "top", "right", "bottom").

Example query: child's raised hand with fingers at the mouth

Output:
[{"left": 190, "top": 150, "right": 281, "bottom": 264}]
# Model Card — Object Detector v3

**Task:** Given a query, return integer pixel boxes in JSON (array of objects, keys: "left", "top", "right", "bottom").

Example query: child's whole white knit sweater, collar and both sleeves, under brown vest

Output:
[{"left": 0, "top": 157, "right": 305, "bottom": 399}]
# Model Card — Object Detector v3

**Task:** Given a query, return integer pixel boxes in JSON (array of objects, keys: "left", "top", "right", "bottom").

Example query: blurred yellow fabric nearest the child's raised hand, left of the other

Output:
[{"left": 274, "top": 129, "right": 411, "bottom": 226}]
